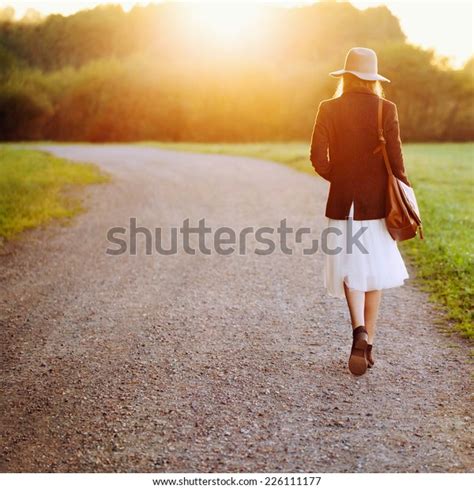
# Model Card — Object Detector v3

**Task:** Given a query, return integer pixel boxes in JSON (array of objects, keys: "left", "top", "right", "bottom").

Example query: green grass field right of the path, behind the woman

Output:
[{"left": 146, "top": 143, "right": 474, "bottom": 339}]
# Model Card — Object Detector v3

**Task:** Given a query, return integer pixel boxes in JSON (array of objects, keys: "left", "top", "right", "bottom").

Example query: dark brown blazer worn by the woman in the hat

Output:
[{"left": 310, "top": 88, "right": 411, "bottom": 220}]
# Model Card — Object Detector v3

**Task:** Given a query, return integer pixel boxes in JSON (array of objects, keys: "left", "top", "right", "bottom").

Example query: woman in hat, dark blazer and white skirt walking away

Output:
[{"left": 310, "top": 47, "right": 411, "bottom": 375}]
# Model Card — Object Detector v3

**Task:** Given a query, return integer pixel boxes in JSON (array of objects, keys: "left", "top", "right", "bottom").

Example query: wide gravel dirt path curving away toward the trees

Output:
[{"left": 0, "top": 145, "right": 474, "bottom": 472}]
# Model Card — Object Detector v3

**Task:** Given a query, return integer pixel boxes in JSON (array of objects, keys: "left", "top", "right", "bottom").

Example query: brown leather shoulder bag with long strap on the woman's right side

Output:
[{"left": 374, "top": 98, "right": 423, "bottom": 241}]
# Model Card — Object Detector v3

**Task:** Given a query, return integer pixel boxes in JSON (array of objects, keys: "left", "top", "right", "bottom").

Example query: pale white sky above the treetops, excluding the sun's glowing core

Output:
[{"left": 0, "top": 0, "right": 473, "bottom": 67}]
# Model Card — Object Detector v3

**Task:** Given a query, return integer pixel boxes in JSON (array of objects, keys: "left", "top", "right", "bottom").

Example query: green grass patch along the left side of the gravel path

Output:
[{"left": 0, "top": 144, "right": 108, "bottom": 244}]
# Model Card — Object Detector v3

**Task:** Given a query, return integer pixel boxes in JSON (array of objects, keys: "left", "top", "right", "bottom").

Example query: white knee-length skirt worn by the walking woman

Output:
[{"left": 324, "top": 202, "right": 408, "bottom": 297}]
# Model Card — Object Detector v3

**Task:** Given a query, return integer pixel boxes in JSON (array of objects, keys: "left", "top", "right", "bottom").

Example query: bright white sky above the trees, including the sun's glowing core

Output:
[{"left": 0, "top": 0, "right": 473, "bottom": 67}]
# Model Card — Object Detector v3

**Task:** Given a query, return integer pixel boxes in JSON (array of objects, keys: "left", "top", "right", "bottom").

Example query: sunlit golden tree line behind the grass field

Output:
[{"left": 0, "top": 2, "right": 474, "bottom": 142}]
